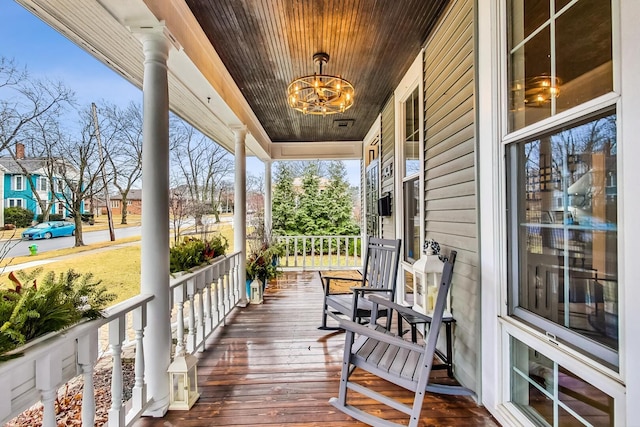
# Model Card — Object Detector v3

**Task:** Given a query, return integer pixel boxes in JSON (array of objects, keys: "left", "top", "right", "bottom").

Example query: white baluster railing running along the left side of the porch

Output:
[{"left": 0, "top": 252, "right": 242, "bottom": 427}]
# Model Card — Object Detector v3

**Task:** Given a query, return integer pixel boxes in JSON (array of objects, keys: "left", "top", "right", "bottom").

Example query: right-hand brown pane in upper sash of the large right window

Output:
[{"left": 555, "top": 0, "right": 613, "bottom": 112}]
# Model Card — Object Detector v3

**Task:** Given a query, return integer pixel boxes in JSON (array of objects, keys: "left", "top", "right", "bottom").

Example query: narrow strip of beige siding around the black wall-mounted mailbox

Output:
[{"left": 380, "top": 97, "right": 398, "bottom": 239}]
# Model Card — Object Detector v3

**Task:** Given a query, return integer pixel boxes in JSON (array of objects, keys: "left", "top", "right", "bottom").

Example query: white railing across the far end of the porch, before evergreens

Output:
[{"left": 276, "top": 236, "right": 363, "bottom": 270}]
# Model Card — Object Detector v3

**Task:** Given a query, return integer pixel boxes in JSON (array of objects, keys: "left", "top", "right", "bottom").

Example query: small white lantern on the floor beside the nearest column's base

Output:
[{"left": 167, "top": 354, "right": 200, "bottom": 411}]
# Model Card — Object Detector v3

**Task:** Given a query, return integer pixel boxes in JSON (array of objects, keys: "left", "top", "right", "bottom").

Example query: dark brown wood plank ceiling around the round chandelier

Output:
[{"left": 186, "top": 0, "right": 447, "bottom": 142}]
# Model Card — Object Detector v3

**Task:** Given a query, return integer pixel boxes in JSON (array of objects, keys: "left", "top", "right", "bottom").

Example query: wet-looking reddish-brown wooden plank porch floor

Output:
[{"left": 135, "top": 272, "right": 498, "bottom": 427}]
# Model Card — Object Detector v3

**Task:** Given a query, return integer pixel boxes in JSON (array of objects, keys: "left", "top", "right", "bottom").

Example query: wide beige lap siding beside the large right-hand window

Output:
[{"left": 424, "top": 0, "right": 480, "bottom": 390}]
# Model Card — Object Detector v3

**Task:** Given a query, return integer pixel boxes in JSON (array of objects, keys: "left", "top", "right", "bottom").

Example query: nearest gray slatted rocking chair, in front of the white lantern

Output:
[{"left": 329, "top": 252, "right": 473, "bottom": 427}]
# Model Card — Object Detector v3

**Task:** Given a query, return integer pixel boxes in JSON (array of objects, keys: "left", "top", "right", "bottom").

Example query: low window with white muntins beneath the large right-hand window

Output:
[{"left": 511, "top": 337, "right": 615, "bottom": 427}]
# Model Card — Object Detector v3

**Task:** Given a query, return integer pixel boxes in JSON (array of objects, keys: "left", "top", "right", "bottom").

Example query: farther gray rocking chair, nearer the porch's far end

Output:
[{"left": 319, "top": 237, "right": 401, "bottom": 330}]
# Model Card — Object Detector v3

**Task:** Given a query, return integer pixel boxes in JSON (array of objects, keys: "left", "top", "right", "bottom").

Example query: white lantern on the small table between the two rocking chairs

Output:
[{"left": 413, "top": 240, "right": 450, "bottom": 315}]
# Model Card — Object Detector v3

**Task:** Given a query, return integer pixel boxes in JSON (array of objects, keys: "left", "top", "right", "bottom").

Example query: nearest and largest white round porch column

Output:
[{"left": 140, "top": 28, "right": 171, "bottom": 417}]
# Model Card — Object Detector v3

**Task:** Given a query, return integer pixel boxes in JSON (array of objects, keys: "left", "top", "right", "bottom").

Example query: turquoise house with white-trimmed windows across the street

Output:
[{"left": 0, "top": 144, "right": 84, "bottom": 222}]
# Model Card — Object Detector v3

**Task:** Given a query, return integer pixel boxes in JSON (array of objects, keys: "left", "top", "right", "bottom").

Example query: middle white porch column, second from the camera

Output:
[{"left": 231, "top": 126, "right": 248, "bottom": 307}]
